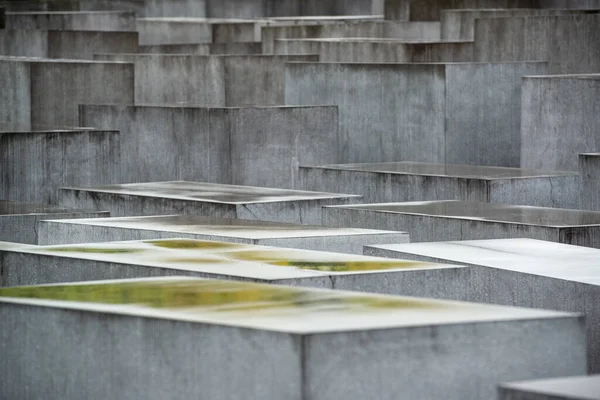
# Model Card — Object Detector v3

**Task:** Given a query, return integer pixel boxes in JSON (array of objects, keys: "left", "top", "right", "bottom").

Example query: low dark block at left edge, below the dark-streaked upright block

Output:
[{"left": 0, "top": 200, "right": 109, "bottom": 244}]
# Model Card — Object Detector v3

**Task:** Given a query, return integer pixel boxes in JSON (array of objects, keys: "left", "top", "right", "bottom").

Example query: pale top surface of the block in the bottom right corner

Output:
[{"left": 501, "top": 375, "right": 600, "bottom": 400}]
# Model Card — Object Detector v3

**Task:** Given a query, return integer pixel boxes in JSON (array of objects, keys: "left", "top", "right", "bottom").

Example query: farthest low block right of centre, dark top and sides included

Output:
[{"left": 300, "top": 161, "right": 579, "bottom": 208}]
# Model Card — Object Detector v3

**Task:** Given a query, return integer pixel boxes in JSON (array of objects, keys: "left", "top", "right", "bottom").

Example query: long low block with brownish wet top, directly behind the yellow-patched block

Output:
[{"left": 35, "top": 214, "right": 409, "bottom": 254}]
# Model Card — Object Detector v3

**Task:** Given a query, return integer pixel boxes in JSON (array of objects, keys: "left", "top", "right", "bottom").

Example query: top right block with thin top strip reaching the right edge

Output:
[{"left": 440, "top": 8, "right": 598, "bottom": 40}]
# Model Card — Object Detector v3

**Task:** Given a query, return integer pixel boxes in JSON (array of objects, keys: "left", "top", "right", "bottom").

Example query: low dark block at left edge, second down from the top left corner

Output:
[{"left": 0, "top": 29, "right": 138, "bottom": 60}]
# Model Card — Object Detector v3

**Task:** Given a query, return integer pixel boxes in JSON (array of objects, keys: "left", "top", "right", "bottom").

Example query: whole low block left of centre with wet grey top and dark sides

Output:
[{"left": 60, "top": 181, "right": 360, "bottom": 225}]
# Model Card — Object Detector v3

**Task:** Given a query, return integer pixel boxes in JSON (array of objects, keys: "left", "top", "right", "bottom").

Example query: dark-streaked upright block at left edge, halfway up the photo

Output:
[{"left": 0, "top": 130, "right": 120, "bottom": 205}]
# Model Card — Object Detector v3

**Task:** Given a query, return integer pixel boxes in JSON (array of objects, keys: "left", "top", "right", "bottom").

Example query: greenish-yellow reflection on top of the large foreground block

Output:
[{"left": 0, "top": 280, "right": 442, "bottom": 313}]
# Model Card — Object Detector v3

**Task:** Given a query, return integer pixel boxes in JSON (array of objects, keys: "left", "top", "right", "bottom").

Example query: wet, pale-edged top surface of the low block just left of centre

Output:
[{"left": 66, "top": 181, "right": 361, "bottom": 204}]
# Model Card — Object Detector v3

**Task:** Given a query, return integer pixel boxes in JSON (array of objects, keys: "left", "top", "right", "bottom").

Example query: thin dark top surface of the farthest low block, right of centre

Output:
[{"left": 311, "top": 161, "right": 577, "bottom": 180}]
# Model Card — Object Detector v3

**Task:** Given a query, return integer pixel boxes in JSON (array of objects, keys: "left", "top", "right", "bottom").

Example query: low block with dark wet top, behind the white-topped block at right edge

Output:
[{"left": 323, "top": 200, "right": 600, "bottom": 248}]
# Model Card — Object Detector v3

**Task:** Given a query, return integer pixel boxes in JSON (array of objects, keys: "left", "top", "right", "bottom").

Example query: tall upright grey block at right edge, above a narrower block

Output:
[{"left": 521, "top": 74, "right": 600, "bottom": 171}]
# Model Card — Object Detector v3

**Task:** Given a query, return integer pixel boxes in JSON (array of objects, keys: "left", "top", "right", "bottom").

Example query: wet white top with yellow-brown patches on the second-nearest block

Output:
[{"left": 0, "top": 239, "right": 461, "bottom": 281}]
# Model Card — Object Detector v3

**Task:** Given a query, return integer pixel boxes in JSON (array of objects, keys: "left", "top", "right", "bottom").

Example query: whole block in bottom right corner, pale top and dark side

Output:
[{"left": 498, "top": 375, "right": 600, "bottom": 400}]
